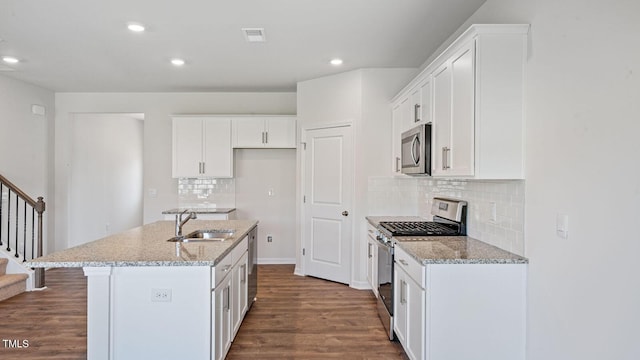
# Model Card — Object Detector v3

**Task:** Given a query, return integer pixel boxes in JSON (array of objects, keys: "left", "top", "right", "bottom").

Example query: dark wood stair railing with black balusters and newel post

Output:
[{"left": 0, "top": 175, "right": 45, "bottom": 288}]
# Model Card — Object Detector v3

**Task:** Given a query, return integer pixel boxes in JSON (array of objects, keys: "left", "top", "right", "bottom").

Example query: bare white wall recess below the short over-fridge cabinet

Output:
[{"left": 234, "top": 149, "right": 296, "bottom": 264}]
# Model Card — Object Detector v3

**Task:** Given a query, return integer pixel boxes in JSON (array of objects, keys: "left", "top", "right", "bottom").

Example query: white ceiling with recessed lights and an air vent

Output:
[{"left": 0, "top": 0, "right": 485, "bottom": 92}]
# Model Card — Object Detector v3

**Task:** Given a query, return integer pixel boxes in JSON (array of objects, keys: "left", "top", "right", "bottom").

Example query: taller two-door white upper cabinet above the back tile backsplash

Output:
[{"left": 172, "top": 116, "right": 233, "bottom": 178}]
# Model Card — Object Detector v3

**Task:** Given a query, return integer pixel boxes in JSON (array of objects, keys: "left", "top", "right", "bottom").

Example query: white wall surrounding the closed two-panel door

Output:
[{"left": 296, "top": 69, "right": 415, "bottom": 287}]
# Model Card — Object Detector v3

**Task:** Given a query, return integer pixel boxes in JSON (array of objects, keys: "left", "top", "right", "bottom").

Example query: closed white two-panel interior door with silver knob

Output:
[{"left": 303, "top": 126, "right": 353, "bottom": 284}]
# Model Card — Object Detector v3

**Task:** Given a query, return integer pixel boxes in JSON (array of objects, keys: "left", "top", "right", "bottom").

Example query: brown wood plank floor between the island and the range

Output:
[{"left": 227, "top": 265, "right": 406, "bottom": 360}]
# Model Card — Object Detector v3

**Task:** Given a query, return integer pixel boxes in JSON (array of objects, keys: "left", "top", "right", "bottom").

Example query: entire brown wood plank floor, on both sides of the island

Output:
[{"left": 0, "top": 265, "right": 406, "bottom": 360}]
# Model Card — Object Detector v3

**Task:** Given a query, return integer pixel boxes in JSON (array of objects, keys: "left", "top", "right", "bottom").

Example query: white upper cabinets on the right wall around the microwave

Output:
[{"left": 392, "top": 25, "right": 529, "bottom": 179}]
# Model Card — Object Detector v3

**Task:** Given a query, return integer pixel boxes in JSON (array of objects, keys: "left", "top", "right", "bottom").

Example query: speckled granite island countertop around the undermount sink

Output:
[{"left": 26, "top": 220, "right": 258, "bottom": 267}]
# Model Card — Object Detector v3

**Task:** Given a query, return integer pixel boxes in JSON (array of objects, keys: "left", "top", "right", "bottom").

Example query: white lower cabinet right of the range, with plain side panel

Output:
[{"left": 394, "top": 245, "right": 527, "bottom": 360}]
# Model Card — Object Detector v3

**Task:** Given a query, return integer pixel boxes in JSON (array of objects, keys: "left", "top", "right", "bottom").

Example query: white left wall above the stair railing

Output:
[{"left": 0, "top": 75, "right": 55, "bottom": 251}]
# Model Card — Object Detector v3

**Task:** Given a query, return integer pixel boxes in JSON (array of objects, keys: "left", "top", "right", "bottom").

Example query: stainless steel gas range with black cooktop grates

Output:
[{"left": 376, "top": 198, "right": 467, "bottom": 340}]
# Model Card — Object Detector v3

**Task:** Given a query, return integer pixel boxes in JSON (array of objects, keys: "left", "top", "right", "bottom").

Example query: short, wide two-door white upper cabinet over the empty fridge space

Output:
[{"left": 232, "top": 116, "right": 296, "bottom": 148}]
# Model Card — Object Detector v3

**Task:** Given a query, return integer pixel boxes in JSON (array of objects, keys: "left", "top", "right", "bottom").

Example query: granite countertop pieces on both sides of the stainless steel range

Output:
[{"left": 366, "top": 216, "right": 529, "bottom": 265}]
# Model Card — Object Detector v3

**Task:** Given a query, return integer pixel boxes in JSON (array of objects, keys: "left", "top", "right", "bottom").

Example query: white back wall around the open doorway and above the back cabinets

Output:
[{"left": 54, "top": 93, "right": 296, "bottom": 250}]
